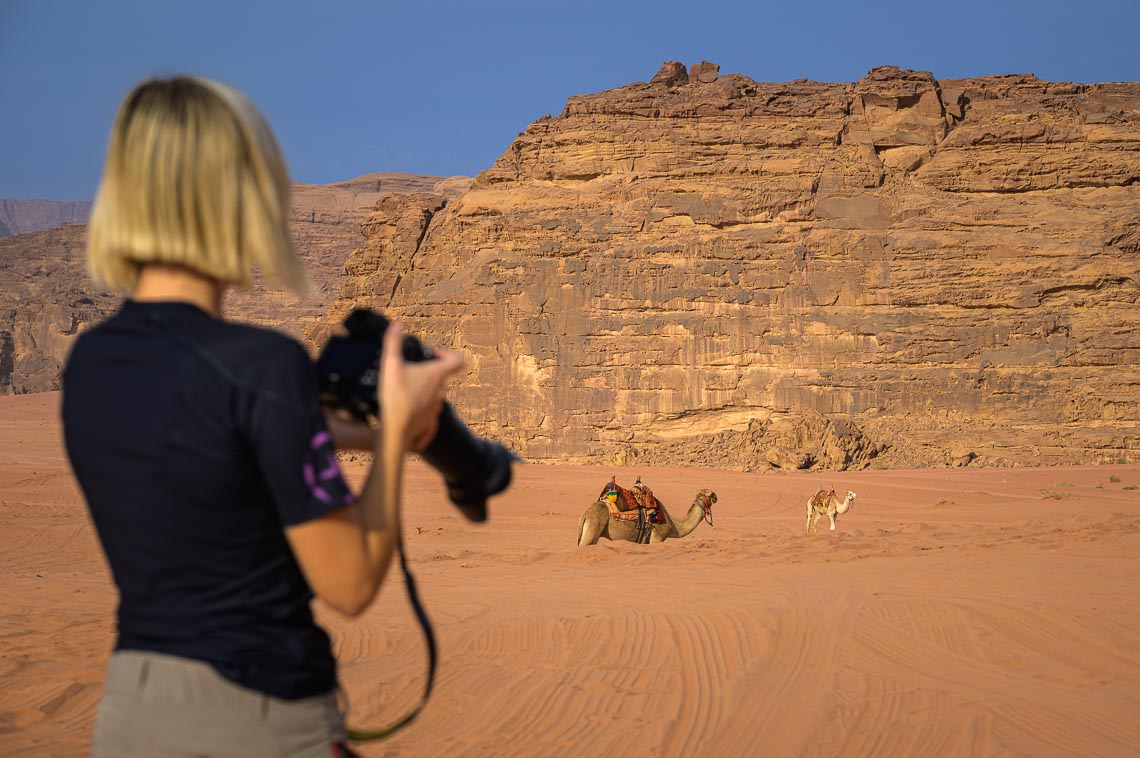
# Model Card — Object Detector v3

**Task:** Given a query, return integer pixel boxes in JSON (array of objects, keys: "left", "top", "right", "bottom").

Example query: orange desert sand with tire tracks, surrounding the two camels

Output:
[{"left": 0, "top": 393, "right": 1140, "bottom": 756}]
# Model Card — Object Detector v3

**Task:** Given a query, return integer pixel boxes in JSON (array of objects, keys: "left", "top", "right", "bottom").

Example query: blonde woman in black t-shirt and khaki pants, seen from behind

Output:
[{"left": 63, "top": 78, "right": 462, "bottom": 758}]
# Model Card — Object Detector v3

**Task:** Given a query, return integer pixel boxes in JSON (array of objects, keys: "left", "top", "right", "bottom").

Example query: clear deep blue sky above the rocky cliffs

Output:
[{"left": 0, "top": 0, "right": 1140, "bottom": 199}]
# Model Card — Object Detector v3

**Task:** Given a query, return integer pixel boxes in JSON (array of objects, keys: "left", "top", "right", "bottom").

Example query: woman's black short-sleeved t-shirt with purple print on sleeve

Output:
[{"left": 63, "top": 300, "right": 352, "bottom": 699}]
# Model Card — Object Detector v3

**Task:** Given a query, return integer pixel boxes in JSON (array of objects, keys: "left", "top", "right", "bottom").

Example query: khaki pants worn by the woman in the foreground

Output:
[{"left": 95, "top": 651, "right": 345, "bottom": 758}]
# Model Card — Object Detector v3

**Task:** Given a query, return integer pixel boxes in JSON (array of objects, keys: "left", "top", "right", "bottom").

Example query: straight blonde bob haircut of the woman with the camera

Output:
[{"left": 87, "top": 76, "right": 314, "bottom": 294}]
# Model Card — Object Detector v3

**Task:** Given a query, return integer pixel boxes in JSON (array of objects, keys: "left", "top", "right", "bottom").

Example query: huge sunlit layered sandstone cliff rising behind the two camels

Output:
[{"left": 325, "top": 62, "right": 1140, "bottom": 470}]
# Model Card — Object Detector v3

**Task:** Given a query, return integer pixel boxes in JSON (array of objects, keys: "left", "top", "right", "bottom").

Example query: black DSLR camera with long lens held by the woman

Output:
[{"left": 317, "top": 308, "right": 518, "bottom": 521}]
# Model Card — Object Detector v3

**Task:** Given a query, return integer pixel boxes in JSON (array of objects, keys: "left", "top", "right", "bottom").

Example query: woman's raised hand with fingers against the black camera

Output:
[{"left": 378, "top": 323, "right": 463, "bottom": 451}]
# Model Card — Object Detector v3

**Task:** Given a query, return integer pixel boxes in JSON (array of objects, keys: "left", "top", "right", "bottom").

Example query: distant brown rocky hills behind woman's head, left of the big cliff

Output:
[{"left": 0, "top": 173, "right": 453, "bottom": 394}]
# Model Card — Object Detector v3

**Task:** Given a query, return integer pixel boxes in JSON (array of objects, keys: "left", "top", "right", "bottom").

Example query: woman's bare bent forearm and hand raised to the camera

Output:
[{"left": 285, "top": 325, "right": 463, "bottom": 616}]
